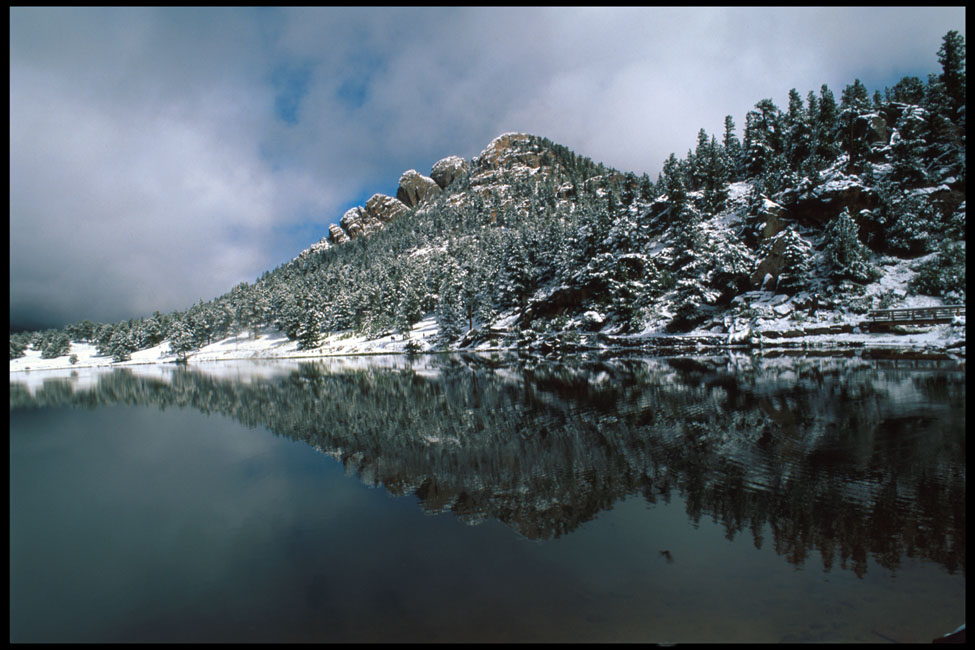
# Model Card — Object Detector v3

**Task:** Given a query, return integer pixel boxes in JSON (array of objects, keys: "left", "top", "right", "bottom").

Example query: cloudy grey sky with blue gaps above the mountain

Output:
[{"left": 10, "top": 7, "right": 965, "bottom": 328}]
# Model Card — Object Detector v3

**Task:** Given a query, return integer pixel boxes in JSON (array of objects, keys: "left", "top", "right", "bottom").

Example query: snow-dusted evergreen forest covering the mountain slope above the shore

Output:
[{"left": 10, "top": 31, "right": 966, "bottom": 360}]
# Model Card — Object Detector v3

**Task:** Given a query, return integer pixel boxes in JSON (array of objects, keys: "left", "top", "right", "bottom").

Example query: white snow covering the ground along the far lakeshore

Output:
[{"left": 10, "top": 284, "right": 966, "bottom": 381}]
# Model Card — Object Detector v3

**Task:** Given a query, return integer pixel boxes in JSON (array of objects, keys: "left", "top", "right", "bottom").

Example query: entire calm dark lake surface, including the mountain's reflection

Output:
[{"left": 10, "top": 356, "right": 966, "bottom": 642}]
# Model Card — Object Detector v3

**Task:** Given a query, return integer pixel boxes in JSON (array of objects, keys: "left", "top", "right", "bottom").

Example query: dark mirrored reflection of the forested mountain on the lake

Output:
[{"left": 10, "top": 355, "right": 965, "bottom": 577}]
